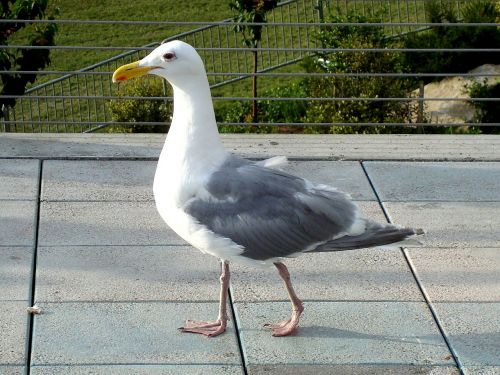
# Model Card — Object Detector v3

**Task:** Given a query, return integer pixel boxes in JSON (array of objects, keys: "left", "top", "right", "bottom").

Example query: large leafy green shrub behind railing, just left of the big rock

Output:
[{"left": 298, "top": 11, "right": 416, "bottom": 133}]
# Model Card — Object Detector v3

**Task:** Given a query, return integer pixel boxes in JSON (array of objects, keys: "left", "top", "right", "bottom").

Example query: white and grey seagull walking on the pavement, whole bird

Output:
[{"left": 113, "top": 41, "right": 424, "bottom": 337}]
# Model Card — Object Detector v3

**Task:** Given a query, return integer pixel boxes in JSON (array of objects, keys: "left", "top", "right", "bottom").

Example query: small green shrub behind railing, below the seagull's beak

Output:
[{"left": 107, "top": 78, "right": 172, "bottom": 133}]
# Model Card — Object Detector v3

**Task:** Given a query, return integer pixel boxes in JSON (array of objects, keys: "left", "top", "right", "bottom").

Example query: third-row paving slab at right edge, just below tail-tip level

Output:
[{"left": 408, "top": 248, "right": 500, "bottom": 302}]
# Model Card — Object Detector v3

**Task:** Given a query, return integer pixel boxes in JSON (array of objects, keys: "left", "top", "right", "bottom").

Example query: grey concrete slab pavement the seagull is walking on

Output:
[{"left": 0, "top": 135, "right": 500, "bottom": 375}]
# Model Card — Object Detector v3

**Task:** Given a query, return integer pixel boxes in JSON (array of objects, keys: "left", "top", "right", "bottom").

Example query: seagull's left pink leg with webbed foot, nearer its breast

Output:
[{"left": 179, "top": 260, "right": 229, "bottom": 337}]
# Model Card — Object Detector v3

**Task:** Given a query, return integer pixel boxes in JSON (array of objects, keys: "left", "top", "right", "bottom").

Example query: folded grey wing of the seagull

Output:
[{"left": 184, "top": 157, "right": 357, "bottom": 260}]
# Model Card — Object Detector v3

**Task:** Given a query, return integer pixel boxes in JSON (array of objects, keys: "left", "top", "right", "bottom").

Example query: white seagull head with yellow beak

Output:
[{"left": 113, "top": 40, "right": 206, "bottom": 85}]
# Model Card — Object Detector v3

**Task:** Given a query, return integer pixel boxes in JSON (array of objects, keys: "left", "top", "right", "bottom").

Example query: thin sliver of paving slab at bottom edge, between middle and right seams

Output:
[{"left": 247, "top": 363, "right": 460, "bottom": 375}]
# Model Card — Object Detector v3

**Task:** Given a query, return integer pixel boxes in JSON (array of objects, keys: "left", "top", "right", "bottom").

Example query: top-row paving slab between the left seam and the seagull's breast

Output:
[{"left": 42, "top": 160, "right": 156, "bottom": 201}]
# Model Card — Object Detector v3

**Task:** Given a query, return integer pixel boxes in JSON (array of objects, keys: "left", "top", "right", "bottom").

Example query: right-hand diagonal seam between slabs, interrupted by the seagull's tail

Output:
[{"left": 359, "top": 160, "right": 465, "bottom": 375}]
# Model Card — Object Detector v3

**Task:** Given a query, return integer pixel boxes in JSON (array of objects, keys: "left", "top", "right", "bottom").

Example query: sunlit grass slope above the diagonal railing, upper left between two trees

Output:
[{"left": 43, "top": 0, "right": 234, "bottom": 74}]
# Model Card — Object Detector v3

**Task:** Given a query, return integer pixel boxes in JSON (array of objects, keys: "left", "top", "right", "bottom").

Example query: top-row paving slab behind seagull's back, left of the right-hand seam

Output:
[{"left": 283, "top": 161, "right": 377, "bottom": 201}]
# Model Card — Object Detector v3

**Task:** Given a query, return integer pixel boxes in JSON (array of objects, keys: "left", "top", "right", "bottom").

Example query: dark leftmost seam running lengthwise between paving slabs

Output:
[{"left": 26, "top": 160, "right": 43, "bottom": 375}]
